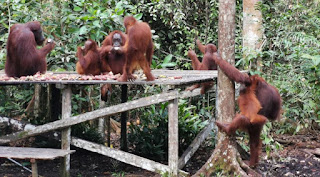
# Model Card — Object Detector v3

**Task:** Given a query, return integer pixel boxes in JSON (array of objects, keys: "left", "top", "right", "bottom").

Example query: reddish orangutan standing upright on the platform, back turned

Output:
[{"left": 118, "top": 16, "right": 155, "bottom": 81}]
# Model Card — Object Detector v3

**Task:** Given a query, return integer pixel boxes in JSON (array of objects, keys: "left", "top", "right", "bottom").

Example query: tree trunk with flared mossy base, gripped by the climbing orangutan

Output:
[{"left": 194, "top": 0, "right": 260, "bottom": 176}]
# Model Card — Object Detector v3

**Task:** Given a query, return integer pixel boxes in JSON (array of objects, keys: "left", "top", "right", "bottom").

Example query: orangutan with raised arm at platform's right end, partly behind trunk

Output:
[{"left": 186, "top": 40, "right": 217, "bottom": 94}]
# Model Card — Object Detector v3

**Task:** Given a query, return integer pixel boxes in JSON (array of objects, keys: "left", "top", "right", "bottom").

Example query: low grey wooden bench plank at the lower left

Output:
[{"left": 0, "top": 146, "right": 75, "bottom": 160}]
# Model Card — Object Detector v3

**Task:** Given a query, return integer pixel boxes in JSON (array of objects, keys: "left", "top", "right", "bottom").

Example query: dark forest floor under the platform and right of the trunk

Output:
[{"left": 0, "top": 130, "right": 320, "bottom": 177}]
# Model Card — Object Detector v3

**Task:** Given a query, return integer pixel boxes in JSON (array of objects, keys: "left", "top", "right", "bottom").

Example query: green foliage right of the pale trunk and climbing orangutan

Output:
[{"left": 261, "top": 1, "right": 320, "bottom": 132}]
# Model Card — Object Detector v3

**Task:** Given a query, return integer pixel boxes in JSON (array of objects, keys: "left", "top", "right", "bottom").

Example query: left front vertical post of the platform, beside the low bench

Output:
[{"left": 61, "top": 85, "right": 71, "bottom": 177}]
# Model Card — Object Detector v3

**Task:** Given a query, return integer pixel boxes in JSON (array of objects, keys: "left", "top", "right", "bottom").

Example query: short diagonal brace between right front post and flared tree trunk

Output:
[{"left": 178, "top": 119, "right": 215, "bottom": 169}]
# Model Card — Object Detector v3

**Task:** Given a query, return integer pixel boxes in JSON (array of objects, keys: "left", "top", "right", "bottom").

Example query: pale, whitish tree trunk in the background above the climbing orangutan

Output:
[{"left": 243, "top": 0, "right": 263, "bottom": 71}]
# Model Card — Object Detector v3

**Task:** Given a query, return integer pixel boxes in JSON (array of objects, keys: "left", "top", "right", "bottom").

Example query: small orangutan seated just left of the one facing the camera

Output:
[{"left": 76, "top": 39, "right": 108, "bottom": 75}]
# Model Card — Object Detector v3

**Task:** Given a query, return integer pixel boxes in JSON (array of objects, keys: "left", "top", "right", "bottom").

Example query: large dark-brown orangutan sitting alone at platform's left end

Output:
[{"left": 5, "top": 21, "right": 55, "bottom": 77}]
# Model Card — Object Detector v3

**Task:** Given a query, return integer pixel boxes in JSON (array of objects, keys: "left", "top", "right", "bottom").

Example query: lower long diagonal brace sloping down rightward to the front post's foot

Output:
[{"left": 71, "top": 138, "right": 188, "bottom": 176}]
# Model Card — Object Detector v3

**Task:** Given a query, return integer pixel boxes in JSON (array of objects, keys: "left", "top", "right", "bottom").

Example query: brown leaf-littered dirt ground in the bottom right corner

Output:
[{"left": 258, "top": 130, "right": 320, "bottom": 177}]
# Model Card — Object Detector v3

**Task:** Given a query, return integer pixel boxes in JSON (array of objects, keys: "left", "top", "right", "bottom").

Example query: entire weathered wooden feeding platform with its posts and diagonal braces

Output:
[{"left": 0, "top": 70, "right": 218, "bottom": 176}]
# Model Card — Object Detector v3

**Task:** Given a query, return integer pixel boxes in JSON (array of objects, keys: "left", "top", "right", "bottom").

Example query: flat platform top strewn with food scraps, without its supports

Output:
[{"left": 0, "top": 70, "right": 218, "bottom": 86}]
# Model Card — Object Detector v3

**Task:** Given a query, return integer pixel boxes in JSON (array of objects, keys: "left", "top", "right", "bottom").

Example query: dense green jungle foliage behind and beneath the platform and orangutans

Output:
[{"left": 0, "top": 0, "right": 320, "bottom": 161}]
